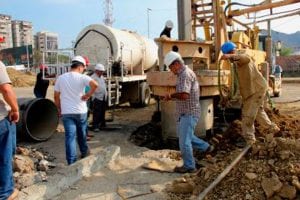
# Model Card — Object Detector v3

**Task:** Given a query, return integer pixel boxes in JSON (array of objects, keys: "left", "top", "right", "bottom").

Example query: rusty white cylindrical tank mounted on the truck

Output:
[{"left": 75, "top": 24, "right": 158, "bottom": 72}]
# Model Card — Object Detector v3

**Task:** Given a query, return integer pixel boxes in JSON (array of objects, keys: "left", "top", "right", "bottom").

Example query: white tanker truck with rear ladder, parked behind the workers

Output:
[{"left": 74, "top": 24, "right": 158, "bottom": 106}]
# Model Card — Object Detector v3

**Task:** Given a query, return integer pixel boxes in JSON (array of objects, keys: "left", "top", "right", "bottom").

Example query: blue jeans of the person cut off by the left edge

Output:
[{"left": 0, "top": 118, "right": 16, "bottom": 199}]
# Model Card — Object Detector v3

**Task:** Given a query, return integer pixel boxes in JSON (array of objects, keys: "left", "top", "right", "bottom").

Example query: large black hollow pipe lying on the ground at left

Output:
[{"left": 17, "top": 98, "right": 59, "bottom": 141}]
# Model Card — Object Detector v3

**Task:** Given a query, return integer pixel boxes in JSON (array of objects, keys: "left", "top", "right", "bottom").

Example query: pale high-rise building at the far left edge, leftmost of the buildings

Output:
[{"left": 0, "top": 14, "right": 13, "bottom": 50}]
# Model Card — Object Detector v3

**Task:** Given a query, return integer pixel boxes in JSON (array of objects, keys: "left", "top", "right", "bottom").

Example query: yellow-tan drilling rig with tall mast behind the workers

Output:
[{"left": 147, "top": 0, "right": 300, "bottom": 139}]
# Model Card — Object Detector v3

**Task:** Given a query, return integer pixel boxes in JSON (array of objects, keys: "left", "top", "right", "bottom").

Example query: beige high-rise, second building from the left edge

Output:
[{"left": 12, "top": 20, "right": 33, "bottom": 47}]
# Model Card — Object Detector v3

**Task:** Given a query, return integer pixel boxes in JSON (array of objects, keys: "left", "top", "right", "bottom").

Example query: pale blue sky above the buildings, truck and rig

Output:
[{"left": 0, "top": 0, "right": 300, "bottom": 48}]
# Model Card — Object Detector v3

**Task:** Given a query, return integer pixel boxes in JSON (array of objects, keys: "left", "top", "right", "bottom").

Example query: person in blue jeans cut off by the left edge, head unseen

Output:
[{"left": 0, "top": 61, "right": 19, "bottom": 200}]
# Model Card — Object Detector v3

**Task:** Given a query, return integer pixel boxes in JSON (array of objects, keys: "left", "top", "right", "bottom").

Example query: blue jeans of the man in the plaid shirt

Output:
[{"left": 177, "top": 114, "right": 209, "bottom": 169}]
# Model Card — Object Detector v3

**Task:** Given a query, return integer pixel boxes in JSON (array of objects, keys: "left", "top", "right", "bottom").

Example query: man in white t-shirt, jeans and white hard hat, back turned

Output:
[{"left": 54, "top": 56, "right": 98, "bottom": 165}]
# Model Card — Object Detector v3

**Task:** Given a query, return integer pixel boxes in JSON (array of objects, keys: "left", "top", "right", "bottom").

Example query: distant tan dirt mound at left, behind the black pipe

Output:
[{"left": 7, "top": 68, "right": 36, "bottom": 87}]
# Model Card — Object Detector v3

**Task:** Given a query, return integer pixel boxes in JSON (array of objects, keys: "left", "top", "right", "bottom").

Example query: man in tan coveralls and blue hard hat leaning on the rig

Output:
[{"left": 221, "top": 41, "right": 280, "bottom": 145}]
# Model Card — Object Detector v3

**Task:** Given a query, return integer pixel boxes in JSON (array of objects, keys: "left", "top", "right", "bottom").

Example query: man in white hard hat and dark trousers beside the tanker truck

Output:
[{"left": 92, "top": 63, "right": 107, "bottom": 132}]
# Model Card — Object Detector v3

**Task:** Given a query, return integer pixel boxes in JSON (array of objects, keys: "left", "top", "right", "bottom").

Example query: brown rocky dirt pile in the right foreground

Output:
[{"left": 166, "top": 107, "right": 300, "bottom": 200}]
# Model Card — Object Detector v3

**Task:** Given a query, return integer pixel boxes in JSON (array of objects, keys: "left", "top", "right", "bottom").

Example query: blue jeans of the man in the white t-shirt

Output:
[{"left": 62, "top": 113, "right": 89, "bottom": 165}]
